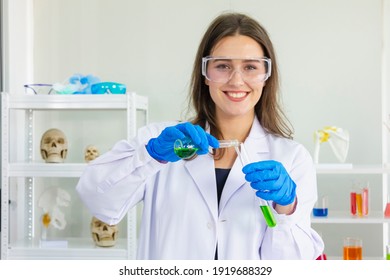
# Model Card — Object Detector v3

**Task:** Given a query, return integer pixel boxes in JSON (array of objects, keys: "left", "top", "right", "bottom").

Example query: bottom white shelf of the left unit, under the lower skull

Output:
[{"left": 8, "top": 238, "right": 128, "bottom": 260}]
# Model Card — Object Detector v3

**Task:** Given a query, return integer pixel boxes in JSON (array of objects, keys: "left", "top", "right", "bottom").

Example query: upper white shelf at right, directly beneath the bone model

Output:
[{"left": 316, "top": 164, "right": 390, "bottom": 174}]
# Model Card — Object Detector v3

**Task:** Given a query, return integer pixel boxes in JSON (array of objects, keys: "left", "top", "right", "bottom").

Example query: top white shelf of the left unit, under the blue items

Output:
[{"left": 4, "top": 93, "right": 148, "bottom": 110}]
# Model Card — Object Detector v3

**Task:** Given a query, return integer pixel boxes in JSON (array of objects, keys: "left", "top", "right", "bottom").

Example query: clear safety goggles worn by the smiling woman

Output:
[{"left": 202, "top": 56, "right": 271, "bottom": 83}]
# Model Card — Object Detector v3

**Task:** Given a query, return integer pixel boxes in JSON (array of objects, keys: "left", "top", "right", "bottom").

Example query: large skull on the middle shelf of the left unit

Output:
[{"left": 41, "top": 128, "right": 68, "bottom": 163}]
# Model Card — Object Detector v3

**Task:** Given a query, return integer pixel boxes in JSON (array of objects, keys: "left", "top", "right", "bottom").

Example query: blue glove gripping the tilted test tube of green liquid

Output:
[{"left": 242, "top": 160, "right": 296, "bottom": 205}]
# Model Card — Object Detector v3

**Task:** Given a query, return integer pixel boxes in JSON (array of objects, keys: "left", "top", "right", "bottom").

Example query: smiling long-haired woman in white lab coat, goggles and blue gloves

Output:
[{"left": 77, "top": 13, "right": 323, "bottom": 259}]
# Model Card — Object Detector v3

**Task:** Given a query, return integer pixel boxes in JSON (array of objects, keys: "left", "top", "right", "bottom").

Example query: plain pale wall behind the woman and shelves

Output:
[{"left": 8, "top": 0, "right": 389, "bottom": 258}]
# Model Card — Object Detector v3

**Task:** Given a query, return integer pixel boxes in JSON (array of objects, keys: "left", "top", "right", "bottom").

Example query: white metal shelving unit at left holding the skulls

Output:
[{"left": 1, "top": 93, "right": 148, "bottom": 259}]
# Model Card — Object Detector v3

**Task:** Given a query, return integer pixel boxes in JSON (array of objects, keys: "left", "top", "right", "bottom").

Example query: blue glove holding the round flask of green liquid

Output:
[{"left": 146, "top": 122, "right": 219, "bottom": 162}]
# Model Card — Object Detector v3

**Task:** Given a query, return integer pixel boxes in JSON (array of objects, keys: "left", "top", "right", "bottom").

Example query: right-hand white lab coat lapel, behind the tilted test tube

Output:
[{"left": 219, "top": 118, "right": 270, "bottom": 212}]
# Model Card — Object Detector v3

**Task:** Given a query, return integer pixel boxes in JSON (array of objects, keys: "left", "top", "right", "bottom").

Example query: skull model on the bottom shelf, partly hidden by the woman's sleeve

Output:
[{"left": 91, "top": 217, "right": 118, "bottom": 247}]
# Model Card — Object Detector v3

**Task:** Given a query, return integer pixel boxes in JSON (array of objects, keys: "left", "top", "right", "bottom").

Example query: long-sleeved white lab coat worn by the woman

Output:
[{"left": 77, "top": 119, "right": 324, "bottom": 260}]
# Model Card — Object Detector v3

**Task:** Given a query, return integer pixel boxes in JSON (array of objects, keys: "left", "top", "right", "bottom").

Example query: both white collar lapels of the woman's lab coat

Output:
[{"left": 185, "top": 118, "right": 269, "bottom": 219}]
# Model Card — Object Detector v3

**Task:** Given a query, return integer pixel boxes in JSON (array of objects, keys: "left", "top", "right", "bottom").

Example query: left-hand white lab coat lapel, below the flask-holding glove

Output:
[{"left": 185, "top": 155, "right": 218, "bottom": 218}]
